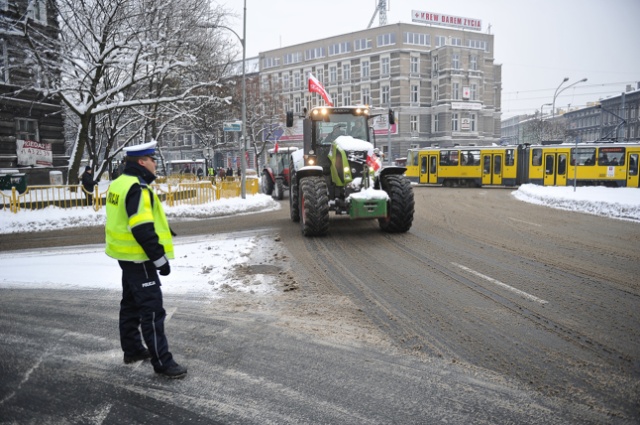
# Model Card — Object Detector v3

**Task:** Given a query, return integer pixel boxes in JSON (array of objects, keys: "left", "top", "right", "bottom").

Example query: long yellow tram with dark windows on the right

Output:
[{"left": 406, "top": 143, "right": 640, "bottom": 187}]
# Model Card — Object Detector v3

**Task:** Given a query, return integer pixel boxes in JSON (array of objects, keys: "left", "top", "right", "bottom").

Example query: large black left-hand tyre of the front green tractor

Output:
[{"left": 300, "top": 176, "right": 329, "bottom": 236}]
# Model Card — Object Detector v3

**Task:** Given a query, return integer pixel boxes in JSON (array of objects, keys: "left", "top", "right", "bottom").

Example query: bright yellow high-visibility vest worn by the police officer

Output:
[{"left": 105, "top": 174, "right": 174, "bottom": 261}]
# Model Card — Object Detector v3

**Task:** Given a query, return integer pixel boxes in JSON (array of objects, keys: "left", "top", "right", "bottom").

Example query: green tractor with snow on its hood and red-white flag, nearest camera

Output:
[{"left": 287, "top": 106, "right": 414, "bottom": 236}]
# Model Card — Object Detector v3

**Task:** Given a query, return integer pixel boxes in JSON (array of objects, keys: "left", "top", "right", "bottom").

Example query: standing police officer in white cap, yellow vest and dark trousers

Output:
[{"left": 106, "top": 141, "right": 187, "bottom": 378}]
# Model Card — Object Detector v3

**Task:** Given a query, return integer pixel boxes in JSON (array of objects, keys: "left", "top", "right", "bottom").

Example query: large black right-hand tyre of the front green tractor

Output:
[{"left": 378, "top": 174, "right": 415, "bottom": 233}]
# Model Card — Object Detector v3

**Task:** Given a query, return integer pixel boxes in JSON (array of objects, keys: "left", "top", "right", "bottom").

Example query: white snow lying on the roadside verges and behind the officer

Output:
[{"left": 0, "top": 185, "right": 640, "bottom": 298}]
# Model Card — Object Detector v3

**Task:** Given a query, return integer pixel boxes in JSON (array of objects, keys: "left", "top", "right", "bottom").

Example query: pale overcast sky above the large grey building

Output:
[{"left": 219, "top": 0, "right": 640, "bottom": 118}]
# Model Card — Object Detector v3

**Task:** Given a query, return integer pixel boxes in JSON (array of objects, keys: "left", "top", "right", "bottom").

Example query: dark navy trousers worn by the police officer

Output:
[{"left": 118, "top": 261, "right": 176, "bottom": 370}]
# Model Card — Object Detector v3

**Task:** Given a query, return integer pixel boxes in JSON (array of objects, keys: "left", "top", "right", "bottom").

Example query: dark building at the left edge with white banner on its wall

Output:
[{"left": 0, "top": 0, "right": 69, "bottom": 184}]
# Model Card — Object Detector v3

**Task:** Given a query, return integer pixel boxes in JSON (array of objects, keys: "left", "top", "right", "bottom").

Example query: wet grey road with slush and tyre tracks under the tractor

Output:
[{"left": 0, "top": 188, "right": 640, "bottom": 424}]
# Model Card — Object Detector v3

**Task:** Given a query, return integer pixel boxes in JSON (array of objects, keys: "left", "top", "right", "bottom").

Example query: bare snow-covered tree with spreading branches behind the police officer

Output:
[{"left": 27, "top": 0, "right": 232, "bottom": 184}]
